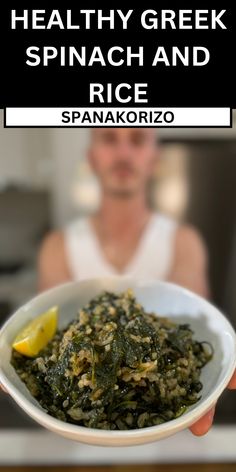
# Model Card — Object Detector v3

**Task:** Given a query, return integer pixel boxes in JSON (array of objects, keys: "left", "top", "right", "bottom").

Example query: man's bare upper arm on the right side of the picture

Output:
[{"left": 168, "top": 225, "right": 209, "bottom": 298}]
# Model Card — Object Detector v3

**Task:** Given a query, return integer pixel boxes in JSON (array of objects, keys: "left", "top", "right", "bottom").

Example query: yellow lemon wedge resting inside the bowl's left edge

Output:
[{"left": 12, "top": 307, "right": 58, "bottom": 357}]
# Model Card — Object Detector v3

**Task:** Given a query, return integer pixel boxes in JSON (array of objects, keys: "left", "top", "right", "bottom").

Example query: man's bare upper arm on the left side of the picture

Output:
[{"left": 38, "top": 231, "right": 71, "bottom": 291}]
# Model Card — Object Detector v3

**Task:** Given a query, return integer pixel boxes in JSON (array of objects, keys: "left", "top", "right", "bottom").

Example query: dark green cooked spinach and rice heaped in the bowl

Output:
[{"left": 12, "top": 290, "right": 212, "bottom": 430}]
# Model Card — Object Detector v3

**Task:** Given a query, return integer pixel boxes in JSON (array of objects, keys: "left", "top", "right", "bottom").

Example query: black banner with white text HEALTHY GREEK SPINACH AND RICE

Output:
[{"left": 0, "top": 0, "right": 236, "bottom": 108}]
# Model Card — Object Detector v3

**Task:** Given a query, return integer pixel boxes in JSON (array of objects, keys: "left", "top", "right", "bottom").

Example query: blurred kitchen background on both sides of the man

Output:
[{"left": 0, "top": 111, "right": 236, "bottom": 463}]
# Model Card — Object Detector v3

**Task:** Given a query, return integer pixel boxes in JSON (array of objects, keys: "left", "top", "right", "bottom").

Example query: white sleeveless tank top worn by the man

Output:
[{"left": 64, "top": 213, "right": 177, "bottom": 280}]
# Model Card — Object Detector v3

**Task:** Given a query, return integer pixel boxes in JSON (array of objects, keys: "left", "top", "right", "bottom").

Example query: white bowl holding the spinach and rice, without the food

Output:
[{"left": 0, "top": 277, "right": 236, "bottom": 446}]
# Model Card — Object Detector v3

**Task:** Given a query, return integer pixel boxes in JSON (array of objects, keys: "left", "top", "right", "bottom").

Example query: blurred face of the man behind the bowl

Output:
[{"left": 89, "top": 128, "right": 157, "bottom": 197}]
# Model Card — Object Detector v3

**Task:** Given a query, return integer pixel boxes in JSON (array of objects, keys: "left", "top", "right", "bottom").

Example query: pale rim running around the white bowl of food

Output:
[{"left": 0, "top": 276, "right": 236, "bottom": 446}]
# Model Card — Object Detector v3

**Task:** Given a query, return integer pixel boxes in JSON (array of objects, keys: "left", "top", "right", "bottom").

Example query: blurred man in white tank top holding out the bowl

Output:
[{"left": 4, "top": 128, "right": 236, "bottom": 435}]
